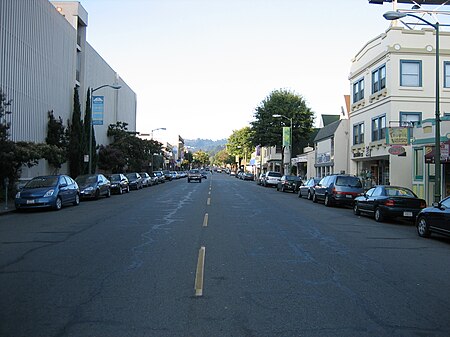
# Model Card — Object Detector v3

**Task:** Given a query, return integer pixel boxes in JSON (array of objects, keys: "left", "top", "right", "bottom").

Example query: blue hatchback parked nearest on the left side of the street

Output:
[{"left": 15, "top": 174, "right": 80, "bottom": 210}]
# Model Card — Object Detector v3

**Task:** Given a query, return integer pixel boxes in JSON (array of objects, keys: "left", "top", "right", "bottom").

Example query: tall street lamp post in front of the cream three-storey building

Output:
[{"left": 383, "top": 11, "right": 441, "bottom": 202}]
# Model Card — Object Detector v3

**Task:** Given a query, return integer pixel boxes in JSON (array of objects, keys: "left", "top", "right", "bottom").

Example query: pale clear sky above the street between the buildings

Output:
[{"left": 75, "top": 0, "right": 392, "bottom": 140}]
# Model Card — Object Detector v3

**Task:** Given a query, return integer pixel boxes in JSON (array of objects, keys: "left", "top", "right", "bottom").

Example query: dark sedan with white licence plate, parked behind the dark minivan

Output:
[{"left": 353, "top": 185, "right": 426, "bottom": 222}]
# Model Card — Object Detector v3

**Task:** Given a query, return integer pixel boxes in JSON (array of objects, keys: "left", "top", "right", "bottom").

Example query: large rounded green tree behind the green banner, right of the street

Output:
[{"left": 251, "top": 89, "right": 314, "bottom": 156}]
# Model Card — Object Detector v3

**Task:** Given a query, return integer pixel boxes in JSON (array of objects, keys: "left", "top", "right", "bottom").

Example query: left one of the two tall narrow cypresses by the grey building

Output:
[{"left": 67, "top": 87, "right": 84, "bottom": 178}]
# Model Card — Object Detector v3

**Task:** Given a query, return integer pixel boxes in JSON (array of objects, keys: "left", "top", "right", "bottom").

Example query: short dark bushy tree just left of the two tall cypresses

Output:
[{"left": 41, "top": 110, "right": 68, "bottom": 173}]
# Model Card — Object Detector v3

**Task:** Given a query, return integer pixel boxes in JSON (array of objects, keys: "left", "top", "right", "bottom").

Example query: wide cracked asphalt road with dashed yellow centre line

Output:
[{"left": 0, "top": 174, "right": 450, "bottom": 337}]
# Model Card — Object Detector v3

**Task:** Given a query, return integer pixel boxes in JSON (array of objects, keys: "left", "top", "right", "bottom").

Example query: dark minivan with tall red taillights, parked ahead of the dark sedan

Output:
[{"left": 313, "top": 174, "right": 364, "bottom": 206}]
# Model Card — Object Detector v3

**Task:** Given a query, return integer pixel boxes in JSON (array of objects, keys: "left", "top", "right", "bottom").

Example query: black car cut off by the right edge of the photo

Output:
[{"left": 416, "top": 197, "right": 450, "bottom": 238}]
